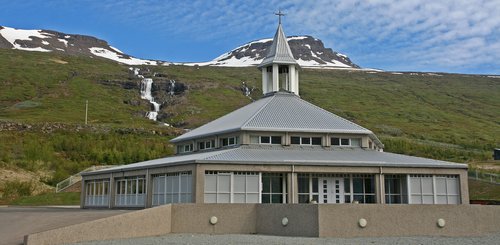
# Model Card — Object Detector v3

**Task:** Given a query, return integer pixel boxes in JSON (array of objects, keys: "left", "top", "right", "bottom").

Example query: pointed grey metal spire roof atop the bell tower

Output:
[{"left": 258, "top": 23, "right": 299, "bottom": 68}]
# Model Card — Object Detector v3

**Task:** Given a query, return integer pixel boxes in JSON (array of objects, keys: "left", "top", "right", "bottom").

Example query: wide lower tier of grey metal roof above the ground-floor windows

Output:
[{"left": 83, "top": 145, "right": 467, "bottom": 175}]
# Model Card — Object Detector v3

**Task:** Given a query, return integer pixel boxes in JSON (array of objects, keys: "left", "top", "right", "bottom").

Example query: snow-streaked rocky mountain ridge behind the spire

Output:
[{"left": 0, "top": 26, "right": 360, "bottom": 68}]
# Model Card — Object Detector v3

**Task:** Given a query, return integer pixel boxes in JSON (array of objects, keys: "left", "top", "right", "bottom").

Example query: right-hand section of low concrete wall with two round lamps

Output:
[{"left": 318, "top": 204, "right": 500, "bottom": 237}]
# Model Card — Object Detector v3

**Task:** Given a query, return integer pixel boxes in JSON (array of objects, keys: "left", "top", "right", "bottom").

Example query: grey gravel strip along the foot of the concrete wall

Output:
[{"left": 71, "top": 233, "right": 500, "bottom": 245}]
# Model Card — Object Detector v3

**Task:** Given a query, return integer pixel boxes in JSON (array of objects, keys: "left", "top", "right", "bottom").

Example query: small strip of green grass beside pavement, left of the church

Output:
[{"left": 9, "top": 192, "right": 80, "bottom": 206}]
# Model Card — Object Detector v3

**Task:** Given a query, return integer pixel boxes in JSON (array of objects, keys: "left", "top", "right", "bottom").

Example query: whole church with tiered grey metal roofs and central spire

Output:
[{"left": 81, "top": 16, "right": 469, "bottom": 208}]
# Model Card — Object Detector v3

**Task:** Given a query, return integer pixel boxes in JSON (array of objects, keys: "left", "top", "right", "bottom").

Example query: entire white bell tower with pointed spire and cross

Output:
[{"left": 257, "top": 11, "right": 300, "bottom": 95}]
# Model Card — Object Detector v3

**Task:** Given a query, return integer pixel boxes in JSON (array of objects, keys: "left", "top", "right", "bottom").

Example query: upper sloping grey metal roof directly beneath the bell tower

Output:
[{"left": 171, "top": 92, "right": 373, "bottom": 143}]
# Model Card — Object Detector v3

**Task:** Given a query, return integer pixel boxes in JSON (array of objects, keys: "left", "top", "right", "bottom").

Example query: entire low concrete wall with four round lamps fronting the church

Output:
[{"left": 25, "top": 204, "right": 500, "bottom": 244}]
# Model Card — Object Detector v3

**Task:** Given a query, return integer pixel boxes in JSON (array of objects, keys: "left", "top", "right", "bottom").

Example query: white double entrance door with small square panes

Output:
[{"left": 318, "top": 177, "right": 344, "bottom": 203}]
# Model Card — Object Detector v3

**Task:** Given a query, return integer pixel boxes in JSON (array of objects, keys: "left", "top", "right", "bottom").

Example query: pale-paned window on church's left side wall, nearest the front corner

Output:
[{"left": 152, "top": 172, "right": 193, "bottom": 206}]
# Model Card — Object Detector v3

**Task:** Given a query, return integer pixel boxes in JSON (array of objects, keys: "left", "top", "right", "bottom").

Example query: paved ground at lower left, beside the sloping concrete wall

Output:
[{"left": 0, "top": 206, "right": 129, "bottom": 245}]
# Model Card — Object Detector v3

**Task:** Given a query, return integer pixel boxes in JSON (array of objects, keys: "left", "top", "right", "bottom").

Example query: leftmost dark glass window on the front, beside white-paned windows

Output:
[{"left": 262, "top": 173, "right": 287, "bottom": 203}]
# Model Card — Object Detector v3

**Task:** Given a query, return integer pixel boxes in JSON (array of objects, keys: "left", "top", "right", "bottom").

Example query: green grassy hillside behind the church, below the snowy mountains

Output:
[{"left": 0, "top": 50, "right": 500, "bottom": 200}]
